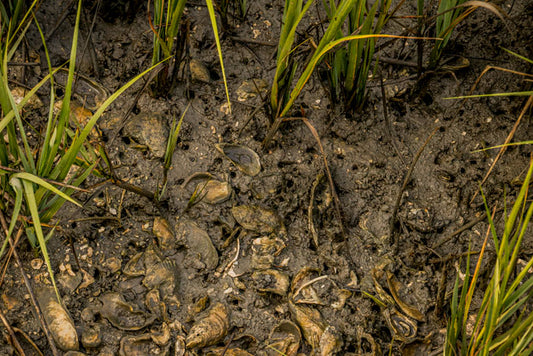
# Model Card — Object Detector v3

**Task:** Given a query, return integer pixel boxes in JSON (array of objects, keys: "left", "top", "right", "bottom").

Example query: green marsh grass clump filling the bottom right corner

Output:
[{"left": 444, "top": 161, "right": 533, "bottom": 355}]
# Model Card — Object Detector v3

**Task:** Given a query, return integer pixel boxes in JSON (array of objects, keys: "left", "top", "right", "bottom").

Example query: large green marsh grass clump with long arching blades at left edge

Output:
[{"left": 0, "top": 0, "right": 163, "bottom": 298}]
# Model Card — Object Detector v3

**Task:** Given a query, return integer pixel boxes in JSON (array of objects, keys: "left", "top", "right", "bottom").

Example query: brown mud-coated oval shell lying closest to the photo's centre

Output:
[{"left": 231, "top": 205, "right": 282, "bottom": 234}]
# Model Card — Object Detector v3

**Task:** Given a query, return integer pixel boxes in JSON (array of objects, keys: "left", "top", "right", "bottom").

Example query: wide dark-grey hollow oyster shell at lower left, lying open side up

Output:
[{"left": 100, "top": 293, "right": 155, "bottom": 330}]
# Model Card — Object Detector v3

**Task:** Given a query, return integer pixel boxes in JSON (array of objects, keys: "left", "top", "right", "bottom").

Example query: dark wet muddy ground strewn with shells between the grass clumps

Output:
[{"left": 0, "top": 0, "right": 533, "bottom": 355}]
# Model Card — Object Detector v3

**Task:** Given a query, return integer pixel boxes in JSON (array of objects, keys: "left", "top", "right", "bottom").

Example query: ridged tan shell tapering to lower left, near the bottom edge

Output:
[{"left": 186, "top": 303, "right": 229, "bottom": 349}]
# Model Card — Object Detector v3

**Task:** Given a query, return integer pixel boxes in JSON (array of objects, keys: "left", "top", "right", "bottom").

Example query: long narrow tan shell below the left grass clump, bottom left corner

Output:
[{"left": 37, "top": 287, "right": 79, "bottom": 351}]
